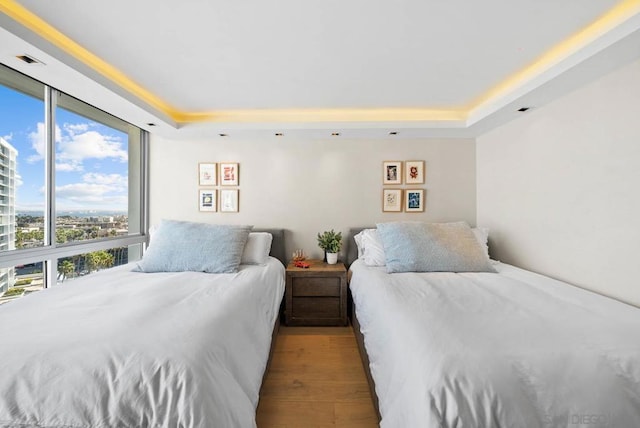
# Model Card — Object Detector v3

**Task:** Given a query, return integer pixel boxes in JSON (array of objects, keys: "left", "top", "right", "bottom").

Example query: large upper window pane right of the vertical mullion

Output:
[{"left": 55, "top": 94, "right": 140, "bottom": 243}]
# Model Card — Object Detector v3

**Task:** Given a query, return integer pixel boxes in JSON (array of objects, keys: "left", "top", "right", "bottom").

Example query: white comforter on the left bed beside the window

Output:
[{"left": 0, "top": 258, "right": 284, "bottom": 428}]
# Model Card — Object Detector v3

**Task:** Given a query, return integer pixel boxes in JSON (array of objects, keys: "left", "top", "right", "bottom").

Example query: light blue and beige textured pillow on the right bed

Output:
[{"left": 377, "top": 222, "right": 495, "bottom": 273}]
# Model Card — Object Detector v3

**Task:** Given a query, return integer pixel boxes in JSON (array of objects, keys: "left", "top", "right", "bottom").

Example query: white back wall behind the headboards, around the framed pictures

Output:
[{"left": 150, "top": 135, "right": 476, "bottom": 257}]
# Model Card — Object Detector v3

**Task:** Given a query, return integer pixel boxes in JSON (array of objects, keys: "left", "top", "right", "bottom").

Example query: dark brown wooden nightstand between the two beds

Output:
[{"left": 285, "top": 260, "right": 348, "bottom": 325}]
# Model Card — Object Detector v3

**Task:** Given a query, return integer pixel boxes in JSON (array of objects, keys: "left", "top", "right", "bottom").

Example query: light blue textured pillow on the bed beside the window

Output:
[{"left": 134, "top": 220, "right": 253, "bottom": 273}]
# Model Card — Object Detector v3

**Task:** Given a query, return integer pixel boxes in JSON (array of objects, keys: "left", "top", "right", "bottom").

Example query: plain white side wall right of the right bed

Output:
[{"left": 476, "top": 61, "right": 640, "bottom": 305}]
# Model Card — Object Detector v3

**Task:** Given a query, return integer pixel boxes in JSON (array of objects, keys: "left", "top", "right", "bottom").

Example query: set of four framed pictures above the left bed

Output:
[{"left": 198, "top": 162, "right": 240, "bottom": 213}]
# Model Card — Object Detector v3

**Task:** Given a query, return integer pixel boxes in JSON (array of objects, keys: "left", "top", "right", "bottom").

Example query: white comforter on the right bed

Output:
[{"left": 350, "top": 261, "right": 640, "bottom": 428}]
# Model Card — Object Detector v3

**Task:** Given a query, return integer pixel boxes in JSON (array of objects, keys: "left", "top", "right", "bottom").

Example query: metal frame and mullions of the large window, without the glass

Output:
[{"left": 0, "top": 64, "right": 149, "bottom": 288}]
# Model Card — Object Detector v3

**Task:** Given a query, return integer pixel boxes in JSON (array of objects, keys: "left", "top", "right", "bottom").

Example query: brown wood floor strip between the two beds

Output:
[{"left": 257, "top": 326, "right": 378, "bottom": 428}]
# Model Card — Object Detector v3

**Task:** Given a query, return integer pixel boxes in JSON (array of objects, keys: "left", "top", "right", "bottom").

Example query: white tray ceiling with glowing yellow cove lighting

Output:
[{"left": 0, "top": 0, "right": 640, "bottom": 136}]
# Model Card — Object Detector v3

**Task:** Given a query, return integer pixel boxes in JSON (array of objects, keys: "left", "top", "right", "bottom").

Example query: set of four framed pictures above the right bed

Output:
[{"left": 382, "top": 160, "right": 426, "bottom": 213}]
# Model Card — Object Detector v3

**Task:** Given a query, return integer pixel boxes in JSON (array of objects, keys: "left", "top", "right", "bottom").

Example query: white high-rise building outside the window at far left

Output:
[{"left": 0, "top": 137, "right": 18, "bottom": 292}]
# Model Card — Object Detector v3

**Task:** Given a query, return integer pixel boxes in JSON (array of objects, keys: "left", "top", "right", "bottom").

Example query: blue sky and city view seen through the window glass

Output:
[{"left": 0, "top": 73, "right": 138, "bottom": 304}]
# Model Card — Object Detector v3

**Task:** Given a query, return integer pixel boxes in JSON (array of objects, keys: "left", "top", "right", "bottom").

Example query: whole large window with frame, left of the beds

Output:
[{"left": 0, "top": 65, "right": 147, "bottom": 298}]
